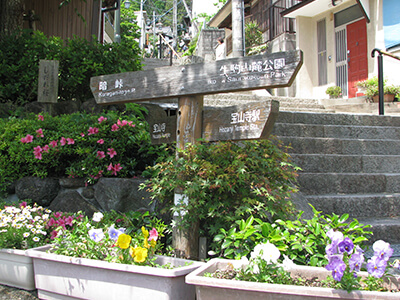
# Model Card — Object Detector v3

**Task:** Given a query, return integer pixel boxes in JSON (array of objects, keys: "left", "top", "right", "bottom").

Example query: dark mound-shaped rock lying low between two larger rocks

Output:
[{"left": 49, "top": 190, "right": 99, "bottom": 216}]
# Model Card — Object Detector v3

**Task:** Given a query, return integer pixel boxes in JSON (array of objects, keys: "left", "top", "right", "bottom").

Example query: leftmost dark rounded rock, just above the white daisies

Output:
[{"left": 15, "top": 177, "right": 60, "bottom": 207}]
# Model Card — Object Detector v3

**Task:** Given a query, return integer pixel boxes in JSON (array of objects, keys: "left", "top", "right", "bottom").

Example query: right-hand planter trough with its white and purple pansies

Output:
[{"left": 186, "top": 230, "right": 400, "bottom": 300}]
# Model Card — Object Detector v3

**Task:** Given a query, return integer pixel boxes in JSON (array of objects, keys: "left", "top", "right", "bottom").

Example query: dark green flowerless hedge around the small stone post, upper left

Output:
[{"left": 0, "top": 30, "right": 141, "bottom": 105}]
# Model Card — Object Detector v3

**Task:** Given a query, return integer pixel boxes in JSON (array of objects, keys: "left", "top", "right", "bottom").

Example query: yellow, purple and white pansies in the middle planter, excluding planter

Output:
[{"left": 50, "top": 212, "right": 166, "bottom": 265}]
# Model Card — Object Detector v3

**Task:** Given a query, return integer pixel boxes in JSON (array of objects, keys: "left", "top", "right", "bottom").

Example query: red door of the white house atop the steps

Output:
[{"left": 346, "top": 19, "right": 368, "bottom": 98}]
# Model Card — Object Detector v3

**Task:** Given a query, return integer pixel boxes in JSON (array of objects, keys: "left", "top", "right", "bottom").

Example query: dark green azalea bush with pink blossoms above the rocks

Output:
[{"left": 0, "top": 109, "right": 167, "bottom": 195}]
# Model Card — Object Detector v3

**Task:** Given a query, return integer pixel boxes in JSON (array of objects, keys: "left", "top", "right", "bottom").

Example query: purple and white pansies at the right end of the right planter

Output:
[{"left": 325, "top": 230, "right": 393, "bottom": 291}]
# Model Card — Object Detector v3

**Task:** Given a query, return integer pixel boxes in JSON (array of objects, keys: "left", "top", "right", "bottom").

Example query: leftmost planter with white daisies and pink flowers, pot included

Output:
[{"left": 0, "top": 201, "right": 79, "bottom": 290}]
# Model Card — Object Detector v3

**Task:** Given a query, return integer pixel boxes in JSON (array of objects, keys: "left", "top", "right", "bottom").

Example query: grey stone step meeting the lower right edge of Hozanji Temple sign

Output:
[{"left": 273, "top": 123, "right": 400, "bottom": 140}]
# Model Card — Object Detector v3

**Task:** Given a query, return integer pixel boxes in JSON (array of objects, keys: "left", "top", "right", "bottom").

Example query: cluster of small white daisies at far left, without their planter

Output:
[{"left": 0, "top": 202, "right": 50, "bottom": 249}]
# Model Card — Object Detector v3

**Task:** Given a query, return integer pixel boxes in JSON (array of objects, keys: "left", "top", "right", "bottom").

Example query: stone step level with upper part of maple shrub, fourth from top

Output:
[{"left": 291, "top": 154, "right": 400, "bottom": 173}]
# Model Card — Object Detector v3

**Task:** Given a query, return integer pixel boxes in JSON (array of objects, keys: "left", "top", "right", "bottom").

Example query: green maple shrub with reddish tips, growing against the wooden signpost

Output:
[{"left": 144, "top": 140, "right": 297, "bottom": 246}]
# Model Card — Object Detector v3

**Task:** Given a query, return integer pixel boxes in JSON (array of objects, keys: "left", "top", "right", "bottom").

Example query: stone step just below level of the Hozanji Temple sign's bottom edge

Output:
[{"left": 272, "top": 136, "right": 400, "bottom": 155}]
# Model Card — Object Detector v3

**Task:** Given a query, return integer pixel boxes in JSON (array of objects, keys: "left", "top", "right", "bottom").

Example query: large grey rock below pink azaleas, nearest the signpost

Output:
[{"left": 94, "top": 178, "right": 154, "bottom": 212}]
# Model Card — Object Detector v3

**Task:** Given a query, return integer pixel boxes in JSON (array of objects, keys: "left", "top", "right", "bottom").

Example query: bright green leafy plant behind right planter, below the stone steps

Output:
[{"left": 214, "top": 208, "right": 372, "bottom": 267}]
